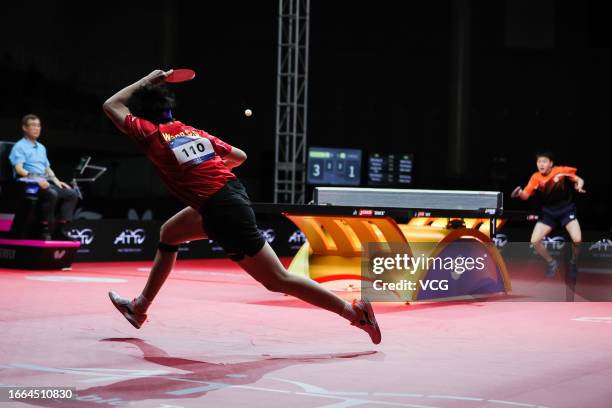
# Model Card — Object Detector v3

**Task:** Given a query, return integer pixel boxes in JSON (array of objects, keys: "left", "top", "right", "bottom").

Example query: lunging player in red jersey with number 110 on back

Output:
[{"left": 103, "top": 70, "right": 381, "bottom": 344}]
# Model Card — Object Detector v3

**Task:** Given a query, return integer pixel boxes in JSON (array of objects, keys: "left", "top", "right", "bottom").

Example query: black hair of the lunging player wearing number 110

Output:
[{"left": 127, "top": 84, "right": 176, "bottom": 124}]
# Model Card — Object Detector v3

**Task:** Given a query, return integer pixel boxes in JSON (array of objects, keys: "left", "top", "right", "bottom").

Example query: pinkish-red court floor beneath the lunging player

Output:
[{"left": 0, "top": 260, "right": 612, "bottom": 408}]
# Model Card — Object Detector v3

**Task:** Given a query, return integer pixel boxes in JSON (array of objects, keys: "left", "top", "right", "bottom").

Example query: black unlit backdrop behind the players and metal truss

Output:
[{"left": 0, "top": 0, "right": 612, "bottom": 229}]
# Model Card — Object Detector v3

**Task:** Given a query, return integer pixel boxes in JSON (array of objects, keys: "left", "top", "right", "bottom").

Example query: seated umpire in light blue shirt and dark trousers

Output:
[{"left": 9, "top": 114, "right": 78, "bottom": 240}]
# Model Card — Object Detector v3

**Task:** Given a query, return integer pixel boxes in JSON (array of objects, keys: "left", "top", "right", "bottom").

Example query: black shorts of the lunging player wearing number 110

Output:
[{"left": 200, "top": 180, "right": 266, "bottom": 261}]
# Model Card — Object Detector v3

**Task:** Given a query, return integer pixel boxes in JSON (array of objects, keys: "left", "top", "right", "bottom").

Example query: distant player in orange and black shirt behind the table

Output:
[{"left": 512, "top": 151, "right": 585, "bottom": 277}]
